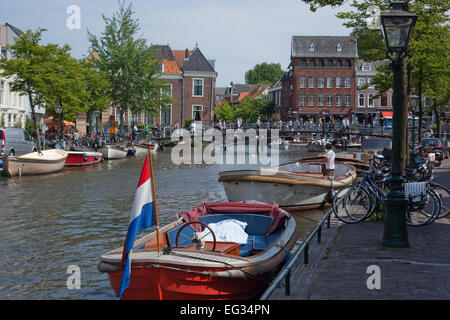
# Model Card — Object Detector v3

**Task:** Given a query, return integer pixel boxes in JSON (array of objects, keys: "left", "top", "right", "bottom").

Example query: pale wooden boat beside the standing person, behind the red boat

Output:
[{"left": 219, "top": 158, "right": 357, "bottom": 210}]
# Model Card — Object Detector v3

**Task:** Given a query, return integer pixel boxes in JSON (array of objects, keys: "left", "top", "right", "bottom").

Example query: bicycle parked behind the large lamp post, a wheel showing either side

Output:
[{"left": 333, "top": 159, "right": 441, "bottom": 226}]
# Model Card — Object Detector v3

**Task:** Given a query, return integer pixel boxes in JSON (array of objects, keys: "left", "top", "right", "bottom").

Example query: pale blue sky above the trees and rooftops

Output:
[{"left": 0, "top": 0, "right": 356, "bottom": 87}]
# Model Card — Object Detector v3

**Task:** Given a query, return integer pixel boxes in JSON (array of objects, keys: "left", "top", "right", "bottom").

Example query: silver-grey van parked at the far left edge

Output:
[{"left": 0, "top": 128, "right": 37, "bottom": 156}]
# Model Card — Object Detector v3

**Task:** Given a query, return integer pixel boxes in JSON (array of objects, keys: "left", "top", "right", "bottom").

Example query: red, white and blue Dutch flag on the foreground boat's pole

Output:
[{"left": 117, "top": 155, "right": 156, "bottom": 298}]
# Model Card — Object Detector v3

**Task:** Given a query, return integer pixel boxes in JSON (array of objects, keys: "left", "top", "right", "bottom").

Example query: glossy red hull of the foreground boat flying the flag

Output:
[{"left": 109, "top": 267, "right": 269, "bottom": 300}]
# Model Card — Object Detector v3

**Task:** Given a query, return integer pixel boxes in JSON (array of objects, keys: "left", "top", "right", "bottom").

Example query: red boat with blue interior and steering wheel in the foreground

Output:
[{"left": 98, "top": 202, "right": 296, "bottom": 300}]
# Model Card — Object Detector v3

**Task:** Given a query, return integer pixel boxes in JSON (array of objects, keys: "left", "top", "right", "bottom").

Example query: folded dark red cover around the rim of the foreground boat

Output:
[{"left": 178, "top": 202, "right": 288, "bottom": 236}]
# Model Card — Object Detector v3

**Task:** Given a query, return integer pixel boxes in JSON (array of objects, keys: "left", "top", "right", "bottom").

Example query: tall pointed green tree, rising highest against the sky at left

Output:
[{"left": 88, "top": 3, "right": 171, "bottom": 130}]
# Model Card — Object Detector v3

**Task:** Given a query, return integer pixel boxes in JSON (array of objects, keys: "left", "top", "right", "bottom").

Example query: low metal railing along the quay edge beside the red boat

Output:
[{"left": 259, "top": 198, "right": 343, "bottom": 300}]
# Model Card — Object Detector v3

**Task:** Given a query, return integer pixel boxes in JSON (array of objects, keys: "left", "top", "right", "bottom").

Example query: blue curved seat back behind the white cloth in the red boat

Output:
[{"left": 199, "top": 213, "right": 273, "bottom": 235}]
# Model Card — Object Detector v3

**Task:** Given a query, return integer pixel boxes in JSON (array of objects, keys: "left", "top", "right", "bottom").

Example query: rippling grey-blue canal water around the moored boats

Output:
[{"left": 0, "top": 148, "right": 324, "bottom": 300}]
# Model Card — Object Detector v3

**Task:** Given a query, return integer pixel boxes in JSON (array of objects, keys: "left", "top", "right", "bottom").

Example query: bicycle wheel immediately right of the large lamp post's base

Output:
[{"left": 406, "top": 188, "right": 441, "bottom": 227}]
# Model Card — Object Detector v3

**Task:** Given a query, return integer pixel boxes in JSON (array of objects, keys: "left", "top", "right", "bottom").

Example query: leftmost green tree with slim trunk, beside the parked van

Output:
[{"left": 0, "top": 28, "right": 58, "bottom": 152}]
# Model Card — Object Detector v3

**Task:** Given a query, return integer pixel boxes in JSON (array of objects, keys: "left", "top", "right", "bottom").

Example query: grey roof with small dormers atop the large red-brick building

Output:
[{"left": 291, "top": 36, "right": 358, "bottom": 58}]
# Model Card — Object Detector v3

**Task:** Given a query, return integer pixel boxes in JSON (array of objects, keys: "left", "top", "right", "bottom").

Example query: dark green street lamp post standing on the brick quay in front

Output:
[{"left": 380, "top": 1, "right": 417, "bottom": 247}]
